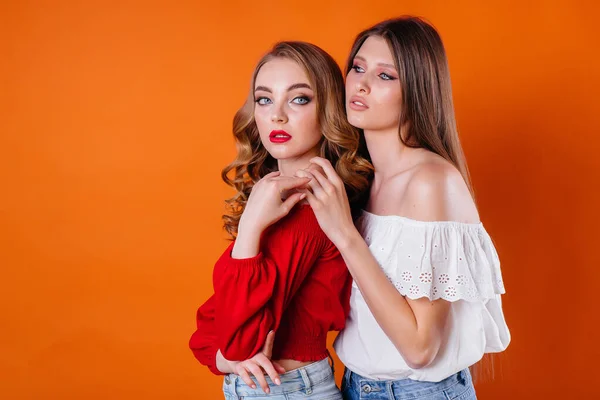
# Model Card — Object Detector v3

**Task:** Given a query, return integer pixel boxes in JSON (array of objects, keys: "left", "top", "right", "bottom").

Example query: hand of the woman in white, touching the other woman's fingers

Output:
[{"left": 296, "top": 157, "right": 356, "bottom": 248}]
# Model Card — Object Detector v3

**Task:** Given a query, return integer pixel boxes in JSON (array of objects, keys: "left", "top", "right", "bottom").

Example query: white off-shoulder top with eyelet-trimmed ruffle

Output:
[{"left": 335, "top": 211, "right": 510, "bottom": 382}]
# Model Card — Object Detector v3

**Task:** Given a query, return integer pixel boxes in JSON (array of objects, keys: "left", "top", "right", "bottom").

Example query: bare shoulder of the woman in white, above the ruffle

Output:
[{"left": 403, "top": 154, "right": 479, "bottom": 223}]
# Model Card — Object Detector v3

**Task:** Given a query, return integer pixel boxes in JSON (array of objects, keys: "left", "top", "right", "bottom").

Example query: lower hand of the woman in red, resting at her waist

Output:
[{"left": 234, "top": 331, "right": 285, "bottom": 394}]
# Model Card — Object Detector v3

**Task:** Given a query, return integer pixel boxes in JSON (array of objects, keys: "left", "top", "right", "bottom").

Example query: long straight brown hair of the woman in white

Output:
[{"left": 346, "top": 16, "right": 473, "bottom": 194}]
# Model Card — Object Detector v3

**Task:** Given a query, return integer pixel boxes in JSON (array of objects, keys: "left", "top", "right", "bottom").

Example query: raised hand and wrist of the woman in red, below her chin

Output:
[{"left": 239, "top": 171, "right": 309, "bottom": 236}]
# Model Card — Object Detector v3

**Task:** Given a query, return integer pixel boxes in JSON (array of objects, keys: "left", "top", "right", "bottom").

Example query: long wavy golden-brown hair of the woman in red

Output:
[{"left": 221, "top": 41, "right": 373, "bottom": 238}]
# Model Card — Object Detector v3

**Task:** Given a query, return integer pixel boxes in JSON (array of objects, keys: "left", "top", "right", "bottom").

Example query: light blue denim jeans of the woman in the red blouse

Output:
[{"left": 223, "top": 358, "right": 342, "bottom": 400}]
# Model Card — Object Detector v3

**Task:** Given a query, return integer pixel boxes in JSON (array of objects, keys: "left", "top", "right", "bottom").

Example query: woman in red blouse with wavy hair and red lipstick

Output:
[{"left": 190, "top": 42, "right": 372, "bottom": 400}]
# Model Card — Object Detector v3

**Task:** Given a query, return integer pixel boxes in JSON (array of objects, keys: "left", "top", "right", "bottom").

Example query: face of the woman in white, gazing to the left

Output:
[{"left": 346, "top": 36, "right": 402, "bottom": 131}]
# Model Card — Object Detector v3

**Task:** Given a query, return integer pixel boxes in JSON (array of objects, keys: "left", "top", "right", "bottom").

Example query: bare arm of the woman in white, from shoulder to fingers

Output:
[{"left": 298, "top": 159, "right": 477, "bottom": 369}]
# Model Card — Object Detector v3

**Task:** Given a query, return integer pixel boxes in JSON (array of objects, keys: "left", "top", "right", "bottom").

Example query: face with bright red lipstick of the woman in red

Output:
[{"left": 254, "top": 58, "right": 322, "bottom": 161}]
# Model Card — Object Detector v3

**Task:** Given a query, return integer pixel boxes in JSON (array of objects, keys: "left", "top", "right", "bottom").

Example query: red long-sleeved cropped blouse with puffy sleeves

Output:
[{"left": 190, "top": 205, "right": 352, "bottom": 374}]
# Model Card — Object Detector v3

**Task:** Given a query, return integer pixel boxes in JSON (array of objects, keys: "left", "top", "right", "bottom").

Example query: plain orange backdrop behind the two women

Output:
[{"left": 0, "top": 0, "right": 600, "bottom": 399}]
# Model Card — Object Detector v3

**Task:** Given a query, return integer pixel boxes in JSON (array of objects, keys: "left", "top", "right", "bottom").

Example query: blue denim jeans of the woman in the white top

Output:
[{"left": 342, "top": 368, "right": 477, "bottom": 400}]
